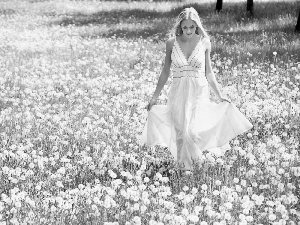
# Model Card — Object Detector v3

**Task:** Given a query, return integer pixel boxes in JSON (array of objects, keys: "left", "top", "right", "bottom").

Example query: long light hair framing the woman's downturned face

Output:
[{"left": 169, "top": 7, "right": 209, "bottom": 38}]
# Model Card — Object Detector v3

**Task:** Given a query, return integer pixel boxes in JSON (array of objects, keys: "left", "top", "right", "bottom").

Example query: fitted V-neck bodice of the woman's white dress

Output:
[{"left": 171, "top": 35, "right": 205, "bottom": 77}]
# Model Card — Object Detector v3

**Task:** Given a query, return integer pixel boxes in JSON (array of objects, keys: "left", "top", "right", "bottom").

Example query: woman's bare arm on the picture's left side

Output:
[{"left": 147, "top": 38, "right": 175, "bottom": 111}]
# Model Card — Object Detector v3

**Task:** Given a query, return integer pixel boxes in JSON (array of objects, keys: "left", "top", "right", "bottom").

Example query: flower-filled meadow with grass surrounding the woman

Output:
[{"left": 0, "top": 0, "right": 300, "bottom": 225}]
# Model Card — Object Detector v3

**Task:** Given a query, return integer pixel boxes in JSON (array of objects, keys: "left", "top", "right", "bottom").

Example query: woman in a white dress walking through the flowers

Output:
[{"left": 141, "top": 7, "right": 252, "bottom": 170}]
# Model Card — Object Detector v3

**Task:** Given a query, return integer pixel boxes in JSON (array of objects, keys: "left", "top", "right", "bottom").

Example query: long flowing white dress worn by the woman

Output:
[{"left": 141, "top": 39, "right": 252, "bottom": 169}]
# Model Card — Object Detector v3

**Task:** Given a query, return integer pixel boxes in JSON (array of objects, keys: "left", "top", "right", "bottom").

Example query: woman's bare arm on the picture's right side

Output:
[{"left": 204, "top": 38, "right": 230, "bottom": 102}]
